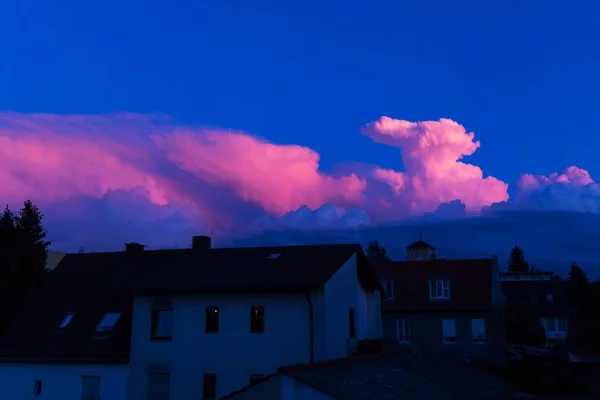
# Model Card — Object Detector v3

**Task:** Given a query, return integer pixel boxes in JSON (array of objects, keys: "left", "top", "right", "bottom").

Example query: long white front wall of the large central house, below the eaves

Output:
[{"left": 129, "top": 294, "right": 310, "bottom": 400}]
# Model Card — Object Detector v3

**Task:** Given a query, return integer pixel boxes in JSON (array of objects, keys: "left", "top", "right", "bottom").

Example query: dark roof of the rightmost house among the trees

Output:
[{"left": 501, "top": 280, "right": 571, "bottom": 316}]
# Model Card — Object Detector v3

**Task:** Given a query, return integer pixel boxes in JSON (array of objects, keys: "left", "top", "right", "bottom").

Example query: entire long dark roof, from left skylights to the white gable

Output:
[{"left": 0, "top": 245, "right": 381, "bottom": 363}]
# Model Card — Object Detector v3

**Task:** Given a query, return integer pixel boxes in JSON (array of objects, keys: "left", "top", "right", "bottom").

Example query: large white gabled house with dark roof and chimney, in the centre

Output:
[{"left": 129, "top": 241, "right": 382, "bottom": 400}]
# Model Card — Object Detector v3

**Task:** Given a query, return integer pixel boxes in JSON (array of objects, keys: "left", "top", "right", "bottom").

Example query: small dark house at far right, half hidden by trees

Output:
[{"left": 502, "top": 279, "right": 573, "bottom": 343}]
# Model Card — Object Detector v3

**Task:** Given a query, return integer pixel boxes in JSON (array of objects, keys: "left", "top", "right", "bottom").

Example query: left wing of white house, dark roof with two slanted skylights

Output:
[{"left": 0, "top": 242, "right": 185, "bottom": 400}]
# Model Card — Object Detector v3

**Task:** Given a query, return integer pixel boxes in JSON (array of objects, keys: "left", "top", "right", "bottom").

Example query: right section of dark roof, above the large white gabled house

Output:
[{"left": 135, "top": 244, "right": 380, "bottom": 295}]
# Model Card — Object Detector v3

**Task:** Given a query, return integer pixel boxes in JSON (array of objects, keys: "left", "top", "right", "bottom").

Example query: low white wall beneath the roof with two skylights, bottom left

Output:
[{"left": 0, "top": 364, "right": 128, "bottom": 400}]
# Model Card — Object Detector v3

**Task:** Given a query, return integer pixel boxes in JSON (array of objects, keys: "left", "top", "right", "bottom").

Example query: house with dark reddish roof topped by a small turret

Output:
[{"left": 375, "top": 240, "right": 505, "bottom": 363}]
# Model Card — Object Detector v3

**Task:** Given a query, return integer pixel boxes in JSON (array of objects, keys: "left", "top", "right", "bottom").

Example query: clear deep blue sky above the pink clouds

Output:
[{"left": 0, "top": 0, "right": 600, "bottom": 189}]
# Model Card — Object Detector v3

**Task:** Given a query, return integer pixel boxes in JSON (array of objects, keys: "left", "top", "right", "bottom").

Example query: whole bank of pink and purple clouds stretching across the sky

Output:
[{"left": 0, "top": 112, "right": 600, "bottom": 251}]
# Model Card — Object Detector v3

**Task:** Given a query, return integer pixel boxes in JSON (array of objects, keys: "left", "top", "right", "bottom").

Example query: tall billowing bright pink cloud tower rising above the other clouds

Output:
[{"left": 362, "top": 117, "right": 508, "bottom": 215}]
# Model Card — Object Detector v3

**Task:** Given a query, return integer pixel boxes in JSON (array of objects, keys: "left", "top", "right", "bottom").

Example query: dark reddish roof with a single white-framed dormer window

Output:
[{"left": 374, "top": 258, "right": 494, "bottom": 311}]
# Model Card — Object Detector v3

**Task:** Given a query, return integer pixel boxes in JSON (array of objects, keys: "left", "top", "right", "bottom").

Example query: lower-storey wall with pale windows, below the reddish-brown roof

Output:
[{"left": 383, "top": 312, "right": 504, "bottom": 362}]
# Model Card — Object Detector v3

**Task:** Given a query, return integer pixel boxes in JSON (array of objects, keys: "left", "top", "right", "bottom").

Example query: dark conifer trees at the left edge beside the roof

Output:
[{"left": 0, "top": 200, "right": 51, "bottom": 332}]
